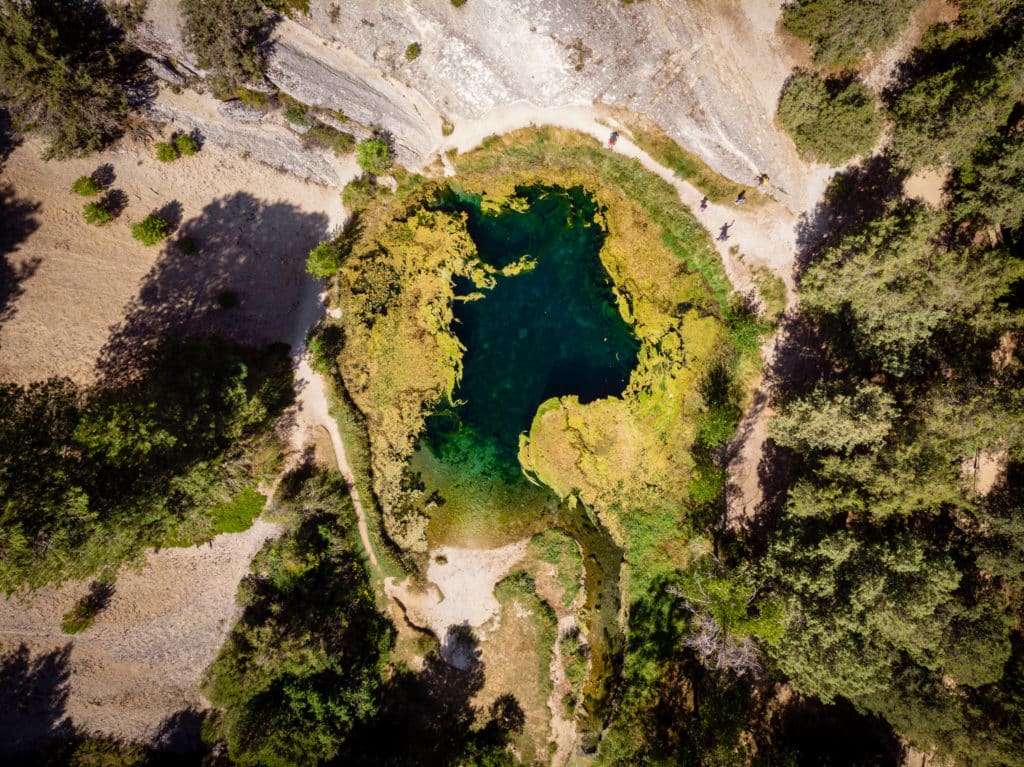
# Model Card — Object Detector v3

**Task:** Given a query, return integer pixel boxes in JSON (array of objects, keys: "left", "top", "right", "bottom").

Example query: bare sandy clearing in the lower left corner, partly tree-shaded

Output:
[{"left": 0, "top": 520, "right": 279, "bottom": 757}]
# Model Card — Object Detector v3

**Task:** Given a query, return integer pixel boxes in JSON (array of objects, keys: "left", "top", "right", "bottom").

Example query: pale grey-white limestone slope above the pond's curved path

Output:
[{"left": 138, "top": 0, "right": 810, "bottom": 208}]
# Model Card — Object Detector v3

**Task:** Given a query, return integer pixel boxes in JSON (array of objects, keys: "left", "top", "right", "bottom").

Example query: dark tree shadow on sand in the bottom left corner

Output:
[{"left": 0, "top": 643, "right": 74, "bottom": 762}]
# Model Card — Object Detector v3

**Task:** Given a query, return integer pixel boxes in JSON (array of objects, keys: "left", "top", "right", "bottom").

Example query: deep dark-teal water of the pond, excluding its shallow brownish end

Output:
[{"left": 427, "top": 187, "right": 638, "bottom": 475}]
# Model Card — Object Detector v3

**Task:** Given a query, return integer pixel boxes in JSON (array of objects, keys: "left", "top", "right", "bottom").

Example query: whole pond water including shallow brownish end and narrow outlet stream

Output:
[{"left": 411, "top": 188, "right": 638, "bottom": 736}]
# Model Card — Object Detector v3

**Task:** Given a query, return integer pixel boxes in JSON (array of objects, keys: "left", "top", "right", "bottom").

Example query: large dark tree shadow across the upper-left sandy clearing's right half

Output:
[{"left": 97, "top": 193, "right": 328, "bottom": 384}]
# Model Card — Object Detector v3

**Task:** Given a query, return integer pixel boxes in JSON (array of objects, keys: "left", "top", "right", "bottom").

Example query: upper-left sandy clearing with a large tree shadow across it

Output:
[{"left": 0, "top": 135, "right": 342, "bottom": 383}]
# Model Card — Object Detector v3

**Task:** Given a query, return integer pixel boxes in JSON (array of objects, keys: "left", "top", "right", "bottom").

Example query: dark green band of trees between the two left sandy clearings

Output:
[{"left": 0, "top": 338, "right": 292, "bottom": 594}]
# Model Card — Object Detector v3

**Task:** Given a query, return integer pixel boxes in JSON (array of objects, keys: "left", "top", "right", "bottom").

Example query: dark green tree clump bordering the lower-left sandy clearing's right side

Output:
[{"left": 206, "top": 472, "right": 393, "bottom": 767}]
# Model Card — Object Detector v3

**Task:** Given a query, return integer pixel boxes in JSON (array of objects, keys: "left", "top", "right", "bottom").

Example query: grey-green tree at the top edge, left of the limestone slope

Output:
[{"left": 179, "top": 0, "right": 269, "bottom": 88}]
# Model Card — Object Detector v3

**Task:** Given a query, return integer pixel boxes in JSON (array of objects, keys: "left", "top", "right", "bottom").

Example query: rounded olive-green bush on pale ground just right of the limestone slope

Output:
[{"left": 778, "top": 73, "right": 882, "bottom": 165}]
